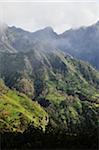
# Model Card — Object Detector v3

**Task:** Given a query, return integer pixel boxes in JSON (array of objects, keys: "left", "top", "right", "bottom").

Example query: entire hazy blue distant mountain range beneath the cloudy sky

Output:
[{"left": 0, "top": 22, "right": 99, "bottom": 69}]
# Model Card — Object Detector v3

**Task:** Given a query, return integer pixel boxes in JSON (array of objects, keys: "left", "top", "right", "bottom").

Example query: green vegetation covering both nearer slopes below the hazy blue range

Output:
[{"left": 0, "top": 49, "right": 99, "bottom": 149}]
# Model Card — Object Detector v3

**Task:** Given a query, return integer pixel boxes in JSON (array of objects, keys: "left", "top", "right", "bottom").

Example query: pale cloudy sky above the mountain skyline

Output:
[{"left": 0, "top": 0, "right": 99, "bottom": 33}]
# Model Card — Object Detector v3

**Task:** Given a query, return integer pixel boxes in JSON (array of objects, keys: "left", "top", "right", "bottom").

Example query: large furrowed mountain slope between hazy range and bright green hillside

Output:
[{"left": 0, "top": 47, "right": 99, "bottom": 133}]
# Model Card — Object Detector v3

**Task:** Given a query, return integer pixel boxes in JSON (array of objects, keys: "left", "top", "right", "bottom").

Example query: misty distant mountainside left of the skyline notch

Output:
[{"left": 0, "top": 26, "right": 58, "bottom": 53}]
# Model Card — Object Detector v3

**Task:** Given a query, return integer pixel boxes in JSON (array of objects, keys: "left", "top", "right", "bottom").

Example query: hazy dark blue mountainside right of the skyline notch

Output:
[{"left": 59, "top": 22, "right": 99, "bottom": 69}]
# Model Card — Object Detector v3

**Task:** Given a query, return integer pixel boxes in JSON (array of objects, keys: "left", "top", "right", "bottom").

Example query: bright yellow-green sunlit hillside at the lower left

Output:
[{"left": 0, "top": 80, "right": 48, "bottom": 132}]
